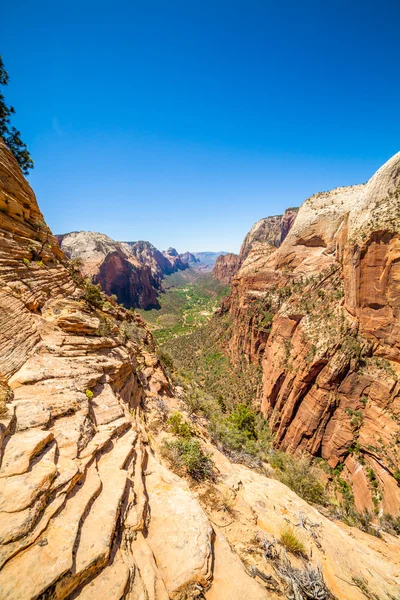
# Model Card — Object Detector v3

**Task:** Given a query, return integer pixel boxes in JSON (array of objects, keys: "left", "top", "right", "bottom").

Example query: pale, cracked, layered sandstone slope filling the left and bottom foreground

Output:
[{"left": 0, "top": 143, "right": 400, "bottom": 600}]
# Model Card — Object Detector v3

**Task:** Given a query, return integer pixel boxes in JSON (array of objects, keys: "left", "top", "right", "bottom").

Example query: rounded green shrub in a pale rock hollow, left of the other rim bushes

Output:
[{"left": 163, "top": 438, "right": 214, "bottom": 481}]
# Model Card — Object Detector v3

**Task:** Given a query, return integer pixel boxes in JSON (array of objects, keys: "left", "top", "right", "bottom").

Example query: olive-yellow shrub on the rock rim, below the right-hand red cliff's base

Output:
[{"left": 269, "top": 451, "right": 328, "bottom": 505}]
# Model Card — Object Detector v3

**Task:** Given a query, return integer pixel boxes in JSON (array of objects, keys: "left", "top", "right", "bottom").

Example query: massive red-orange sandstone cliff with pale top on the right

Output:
[{"left": 230, "top": 154, "right": 400, "bottom": 515}]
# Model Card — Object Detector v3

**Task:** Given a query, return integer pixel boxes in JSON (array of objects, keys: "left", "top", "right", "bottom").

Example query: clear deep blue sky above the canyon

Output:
[{"left": 0, "top": 0, "right": 400, "bottom": 251}]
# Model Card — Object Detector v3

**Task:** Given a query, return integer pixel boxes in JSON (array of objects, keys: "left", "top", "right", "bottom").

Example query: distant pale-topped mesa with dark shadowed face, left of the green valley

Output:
[{"left": 57, "top": 231, "right": 194, "bottom": 309}]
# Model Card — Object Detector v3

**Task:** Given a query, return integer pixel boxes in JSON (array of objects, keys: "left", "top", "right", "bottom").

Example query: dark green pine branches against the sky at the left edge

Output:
[{"left": 0, "top": 56, "right": 33, "bottom": 175}]
